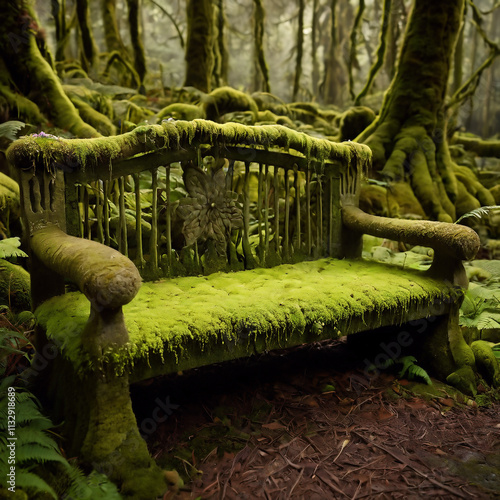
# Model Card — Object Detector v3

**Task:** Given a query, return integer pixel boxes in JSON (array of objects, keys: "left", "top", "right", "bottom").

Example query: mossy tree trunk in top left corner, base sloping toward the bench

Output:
[{"left": 0, "top": 0, "right": 100, "bottom": 137}]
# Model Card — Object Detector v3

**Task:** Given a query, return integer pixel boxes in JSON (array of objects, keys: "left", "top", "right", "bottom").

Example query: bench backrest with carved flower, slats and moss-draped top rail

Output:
[{"left": 8, "top": 120, "right": 371, "bottom": 278}]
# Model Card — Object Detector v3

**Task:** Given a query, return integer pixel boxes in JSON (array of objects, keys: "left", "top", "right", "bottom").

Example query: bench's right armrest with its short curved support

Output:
[{"left": 342, "top": 205, "right": 481, "bottom": 288}]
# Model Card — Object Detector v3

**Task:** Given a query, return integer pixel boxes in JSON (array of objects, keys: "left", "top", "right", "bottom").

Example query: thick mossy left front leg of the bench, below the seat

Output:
[{"left": 47, "top": 360, "right": 167, "bottom": 500}]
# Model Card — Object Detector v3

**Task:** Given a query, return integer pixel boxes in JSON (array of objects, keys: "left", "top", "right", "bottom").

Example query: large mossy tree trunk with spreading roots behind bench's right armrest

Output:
[{"left": 356, "top": 0, "right": 494, "bottom": 221}]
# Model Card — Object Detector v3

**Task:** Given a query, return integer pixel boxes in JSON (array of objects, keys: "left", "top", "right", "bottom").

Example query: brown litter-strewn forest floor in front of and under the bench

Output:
[{"left": 133, "top": 341, "right": 500, "bottom": 500}]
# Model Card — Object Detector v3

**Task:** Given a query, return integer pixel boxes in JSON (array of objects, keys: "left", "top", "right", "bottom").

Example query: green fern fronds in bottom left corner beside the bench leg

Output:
[{"left": 0, "top": 309, "right": 121, "bottom": 500}]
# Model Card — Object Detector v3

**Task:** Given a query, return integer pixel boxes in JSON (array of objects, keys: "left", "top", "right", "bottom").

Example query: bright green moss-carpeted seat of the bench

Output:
[{"left": 36, "top": 258, "right": 458, "bottom": 381}]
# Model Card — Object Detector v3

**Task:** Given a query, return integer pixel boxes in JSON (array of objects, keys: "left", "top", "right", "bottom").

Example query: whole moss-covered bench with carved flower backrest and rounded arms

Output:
[{"left": 7, "top": 120, "right": 479, "bottom": 499}]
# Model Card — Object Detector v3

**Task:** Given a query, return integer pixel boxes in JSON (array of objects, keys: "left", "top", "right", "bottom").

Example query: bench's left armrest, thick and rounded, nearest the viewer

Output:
[{"left": 30, "top": 226, "right": 141, "bottom": 310}]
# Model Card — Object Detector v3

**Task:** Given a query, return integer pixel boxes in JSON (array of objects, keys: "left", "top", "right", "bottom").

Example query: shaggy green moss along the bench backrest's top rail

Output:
[{"left": 7, "top": 119, "right": 371, "bottom": 177}]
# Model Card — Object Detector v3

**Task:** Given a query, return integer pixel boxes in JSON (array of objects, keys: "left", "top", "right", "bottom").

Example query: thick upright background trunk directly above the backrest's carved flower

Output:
[{"left": 184, "top": 0, "right": 214, "bottom": 92}]
